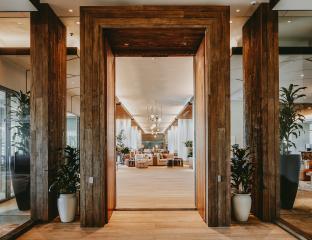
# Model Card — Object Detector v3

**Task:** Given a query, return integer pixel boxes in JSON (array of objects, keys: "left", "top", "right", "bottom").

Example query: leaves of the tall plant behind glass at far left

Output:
[{"left": 10, "top": 91, "right": 30, "bottom": 154}]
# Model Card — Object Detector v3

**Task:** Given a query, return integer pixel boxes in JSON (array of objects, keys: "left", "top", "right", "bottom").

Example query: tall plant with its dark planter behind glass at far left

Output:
[{"left": 9, "top": 91, "right": 30, "bottom": 211}]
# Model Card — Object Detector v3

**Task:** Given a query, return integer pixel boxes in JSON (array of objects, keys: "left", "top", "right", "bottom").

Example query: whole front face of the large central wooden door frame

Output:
[{"left": 80, "top": 6, "right": 231, "bottom": 227}]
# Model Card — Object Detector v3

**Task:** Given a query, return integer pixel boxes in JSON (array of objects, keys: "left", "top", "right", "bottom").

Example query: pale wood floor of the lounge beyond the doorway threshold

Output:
[{"left": 117, "top": 166, "right": 195, "bottom": 208}]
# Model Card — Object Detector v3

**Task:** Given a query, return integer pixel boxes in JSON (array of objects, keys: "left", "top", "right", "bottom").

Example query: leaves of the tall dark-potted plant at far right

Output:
[{"left": 279, "top": 84, "right": 306, "bottom": 154}]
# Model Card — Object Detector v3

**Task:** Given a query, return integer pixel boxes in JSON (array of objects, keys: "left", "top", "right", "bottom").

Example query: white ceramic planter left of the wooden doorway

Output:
[{"left": 57, "top": 193, "right": 77, "bottom": 222}]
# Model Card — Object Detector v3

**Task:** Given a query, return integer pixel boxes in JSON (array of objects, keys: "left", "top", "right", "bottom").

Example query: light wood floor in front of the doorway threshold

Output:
[{"left": 19, "top": 211, "right": 295, "bottom": 240}]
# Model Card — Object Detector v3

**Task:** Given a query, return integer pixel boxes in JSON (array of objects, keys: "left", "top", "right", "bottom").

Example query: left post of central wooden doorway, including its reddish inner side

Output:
[{"left": 80, "top": 15, "right": 116, "bottom": 227}]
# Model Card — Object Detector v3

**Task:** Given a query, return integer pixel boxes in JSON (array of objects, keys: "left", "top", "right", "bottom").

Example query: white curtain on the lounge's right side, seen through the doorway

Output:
[{"left": 178, "top": 119, "right": 194, "bottom": 160}]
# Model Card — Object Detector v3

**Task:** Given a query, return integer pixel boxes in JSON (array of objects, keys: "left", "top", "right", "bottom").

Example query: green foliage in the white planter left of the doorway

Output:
[{"left": 49, "top": 146, "right": 80, "bottom": 194}]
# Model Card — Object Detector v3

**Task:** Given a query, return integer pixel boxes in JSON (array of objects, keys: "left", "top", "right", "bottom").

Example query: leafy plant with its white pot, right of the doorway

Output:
[{"left": 231, "top": 144, "right": 254, "bottom": 222}]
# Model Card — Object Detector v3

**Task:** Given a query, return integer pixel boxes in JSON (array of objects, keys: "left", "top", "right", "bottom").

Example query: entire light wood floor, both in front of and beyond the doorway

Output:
[{"left": 19, "top": 167, "right": 294, "bottom": 240}]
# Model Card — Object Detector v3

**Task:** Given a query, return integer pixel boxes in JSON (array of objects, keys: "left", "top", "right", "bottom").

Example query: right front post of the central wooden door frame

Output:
[{"left": 205, "top": 7, "right": 231, "bottom": 227}]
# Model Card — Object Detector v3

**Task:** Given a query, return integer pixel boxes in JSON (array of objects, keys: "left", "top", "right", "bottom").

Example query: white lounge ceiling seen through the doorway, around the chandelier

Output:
[{"left": 116, "top": 57, "right": 193, "bottom": 133}]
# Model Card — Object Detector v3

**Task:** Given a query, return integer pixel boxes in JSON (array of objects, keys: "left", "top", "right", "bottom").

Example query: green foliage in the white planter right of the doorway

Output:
[{"left": 231, "top": 144, "right": 255, "bottom": 194}]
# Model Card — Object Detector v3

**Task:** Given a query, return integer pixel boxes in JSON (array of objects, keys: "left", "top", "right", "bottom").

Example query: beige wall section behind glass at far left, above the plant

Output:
[{"left": 0, "top": 57, "right": 29, "bottom": 91}]
